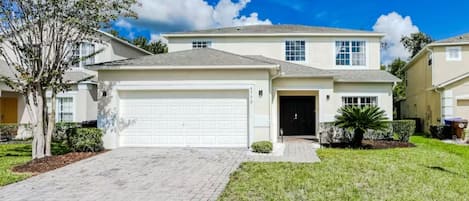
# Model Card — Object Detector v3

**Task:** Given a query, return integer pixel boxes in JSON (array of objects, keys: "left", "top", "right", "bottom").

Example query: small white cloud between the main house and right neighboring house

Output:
[{"left": 373, "top": 12, "right": 419, "bottom": 64}]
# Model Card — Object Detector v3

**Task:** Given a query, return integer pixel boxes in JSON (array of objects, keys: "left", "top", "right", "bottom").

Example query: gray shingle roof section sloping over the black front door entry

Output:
[{"left": 247, "top": 55, "right": 334, "bottom": 77}]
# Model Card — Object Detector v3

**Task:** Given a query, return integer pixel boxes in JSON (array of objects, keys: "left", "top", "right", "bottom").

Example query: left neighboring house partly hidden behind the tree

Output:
[{"left": 0, "top": 31, "right": 151, "bottom": 137}]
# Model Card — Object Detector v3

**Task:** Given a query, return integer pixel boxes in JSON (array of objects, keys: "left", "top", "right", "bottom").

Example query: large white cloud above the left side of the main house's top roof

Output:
[{"left": 115, "top": 0, "right": 272, "bottom": 37}]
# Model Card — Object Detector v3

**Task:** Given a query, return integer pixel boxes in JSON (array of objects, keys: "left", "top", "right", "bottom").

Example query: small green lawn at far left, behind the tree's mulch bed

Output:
[{"left": 0, "top": 143, "right": 70, "bottom": 186}]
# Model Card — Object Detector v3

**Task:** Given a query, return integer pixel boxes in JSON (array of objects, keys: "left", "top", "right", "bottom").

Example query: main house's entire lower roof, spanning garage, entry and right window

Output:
[{"left": 88, "top": 48, "right": 400, "bottom": 82}]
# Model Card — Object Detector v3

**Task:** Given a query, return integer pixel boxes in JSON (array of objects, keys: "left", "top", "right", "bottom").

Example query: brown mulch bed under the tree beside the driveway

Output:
[{"left": 12, "top": 151, "right": 106, "bottom": 175}]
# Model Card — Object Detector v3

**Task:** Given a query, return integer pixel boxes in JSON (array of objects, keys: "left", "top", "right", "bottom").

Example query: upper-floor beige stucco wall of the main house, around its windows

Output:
[{"left": 168, "top": 37, "right": 381, "bottom": 69}]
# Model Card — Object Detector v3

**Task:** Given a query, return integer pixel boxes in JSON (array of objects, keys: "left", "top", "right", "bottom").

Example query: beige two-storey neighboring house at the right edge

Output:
[{"left": 402, "top": 34, "right": 469, "bottom": 132}]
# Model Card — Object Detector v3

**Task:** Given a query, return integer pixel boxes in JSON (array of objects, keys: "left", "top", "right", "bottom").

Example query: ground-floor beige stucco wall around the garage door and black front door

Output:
[{"left": 98, "top": 70, "right": 392, "bottom": 148}]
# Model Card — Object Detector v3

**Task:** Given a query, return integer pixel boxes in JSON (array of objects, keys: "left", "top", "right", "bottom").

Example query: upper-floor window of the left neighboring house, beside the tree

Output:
[{"left": 72, "top": 42, "right": 96, "bottom": 67}]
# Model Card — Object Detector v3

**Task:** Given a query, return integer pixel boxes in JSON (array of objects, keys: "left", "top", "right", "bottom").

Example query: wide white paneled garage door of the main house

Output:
[{"left": 119, "top": 90, "right": 248, "bottom": 147}]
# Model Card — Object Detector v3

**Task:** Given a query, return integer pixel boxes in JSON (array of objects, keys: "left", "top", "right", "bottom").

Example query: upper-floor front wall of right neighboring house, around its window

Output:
[{"left": 432, "top": 45, "right": 469, "bottom": 85}]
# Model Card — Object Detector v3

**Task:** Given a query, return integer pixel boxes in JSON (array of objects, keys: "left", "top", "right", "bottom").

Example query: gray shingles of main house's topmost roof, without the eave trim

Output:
[{"left": 168, "top": 25, "right": 377, "bottom": 35}]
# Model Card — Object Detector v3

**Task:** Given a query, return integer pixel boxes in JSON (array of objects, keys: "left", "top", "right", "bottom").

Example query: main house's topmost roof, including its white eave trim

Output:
[{"left": 163, "top": 25, "right": 384, "bottom": 37}]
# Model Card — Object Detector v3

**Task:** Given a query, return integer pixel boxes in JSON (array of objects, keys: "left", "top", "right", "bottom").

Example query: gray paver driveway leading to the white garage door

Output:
[{"left": 0, "top": 148, "right": 246, "bottom": 201}]
